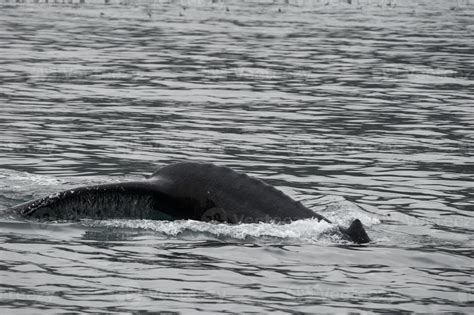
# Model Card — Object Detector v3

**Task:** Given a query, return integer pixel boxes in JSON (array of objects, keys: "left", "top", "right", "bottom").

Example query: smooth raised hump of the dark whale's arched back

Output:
[{"left": 150, "top": 162, "right": 326, "bottom": 222}]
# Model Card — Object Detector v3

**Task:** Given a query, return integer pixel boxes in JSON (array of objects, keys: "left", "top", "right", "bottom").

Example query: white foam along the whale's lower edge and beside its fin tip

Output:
[{"left": 76, "top": 195, "right": 380, "bottom": 243}]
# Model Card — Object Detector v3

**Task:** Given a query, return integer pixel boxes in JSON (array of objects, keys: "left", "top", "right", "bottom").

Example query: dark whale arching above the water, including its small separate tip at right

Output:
[{"left": 1, "top": 162, "right": 370, "bottom": 244}]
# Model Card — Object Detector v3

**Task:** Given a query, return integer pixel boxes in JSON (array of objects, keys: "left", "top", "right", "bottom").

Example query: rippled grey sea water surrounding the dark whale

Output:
[{"left": 0, "top": 0, "right": 474, "bottom": 314}]
